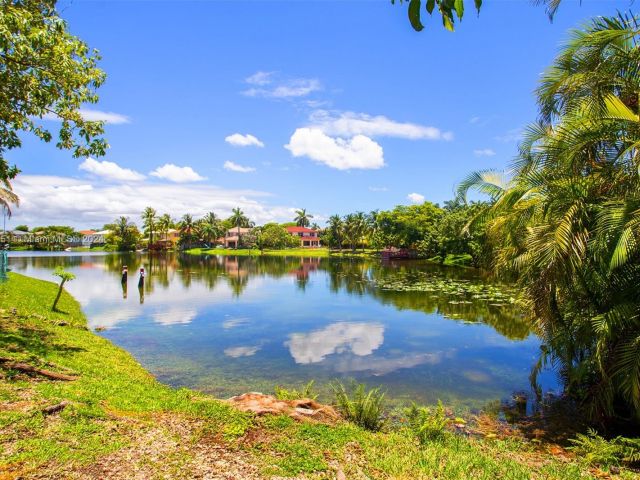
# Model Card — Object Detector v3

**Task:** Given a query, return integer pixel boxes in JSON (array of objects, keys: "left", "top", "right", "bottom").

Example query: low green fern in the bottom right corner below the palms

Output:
[{"left": 569, "top": 429, "right": 640, "bottom": 465}]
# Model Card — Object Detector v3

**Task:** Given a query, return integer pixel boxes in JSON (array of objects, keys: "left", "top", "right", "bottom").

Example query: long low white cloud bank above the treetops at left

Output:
[{"left": 12, "top": 174, "right": 291, "bottom": 228}]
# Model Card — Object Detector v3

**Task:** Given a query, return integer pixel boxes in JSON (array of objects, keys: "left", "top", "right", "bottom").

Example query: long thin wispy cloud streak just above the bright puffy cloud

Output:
[{"left": 309, "top": 110, "right": 453, "bottom": 140}]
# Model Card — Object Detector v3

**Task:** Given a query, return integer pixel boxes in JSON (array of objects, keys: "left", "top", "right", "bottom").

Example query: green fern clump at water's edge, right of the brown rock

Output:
[{"left": 331, "top": 382, "right": 384, "bottom": 432}]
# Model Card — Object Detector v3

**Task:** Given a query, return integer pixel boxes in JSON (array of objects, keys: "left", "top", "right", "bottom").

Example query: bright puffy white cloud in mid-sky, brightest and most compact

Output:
[{"left": 285, "top": 128, "right": 384, "bottom": 170}]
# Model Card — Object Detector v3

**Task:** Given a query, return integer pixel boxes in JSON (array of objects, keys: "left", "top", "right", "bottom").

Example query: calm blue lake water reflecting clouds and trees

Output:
[{"left": 9, "top": 252, "right": 553, "bottom": 408}]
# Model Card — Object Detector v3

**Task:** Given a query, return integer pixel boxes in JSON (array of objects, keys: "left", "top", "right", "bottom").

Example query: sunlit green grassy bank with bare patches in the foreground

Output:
[{"left": 0, "top": 274, "right": 634, "bottom": 480}]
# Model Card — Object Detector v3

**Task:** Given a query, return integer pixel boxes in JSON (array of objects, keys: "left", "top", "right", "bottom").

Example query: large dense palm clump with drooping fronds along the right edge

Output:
[{"left": 460, "top": 16, "right": 640, "bottom": 422}]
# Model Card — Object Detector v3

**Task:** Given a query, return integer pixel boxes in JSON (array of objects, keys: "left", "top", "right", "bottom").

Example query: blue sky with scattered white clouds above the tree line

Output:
[{"left": 7, "top": 0, "right": 631, "bottom": 228}]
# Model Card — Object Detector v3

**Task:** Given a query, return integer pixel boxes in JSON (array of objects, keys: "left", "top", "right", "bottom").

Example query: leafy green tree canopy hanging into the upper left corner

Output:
[{"left": 0, "top": 0, "right": 108, "bottom": 189}]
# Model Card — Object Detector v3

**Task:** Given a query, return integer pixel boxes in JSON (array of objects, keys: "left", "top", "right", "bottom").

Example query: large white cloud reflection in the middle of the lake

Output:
[{"left": 285, "top": 322, "right": 384, "bottom": 364}]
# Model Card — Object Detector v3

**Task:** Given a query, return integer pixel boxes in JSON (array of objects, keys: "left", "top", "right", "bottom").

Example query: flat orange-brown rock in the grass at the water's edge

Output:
[{"left": 227, "top": 392, "right": 340, "bottom": 423}]
